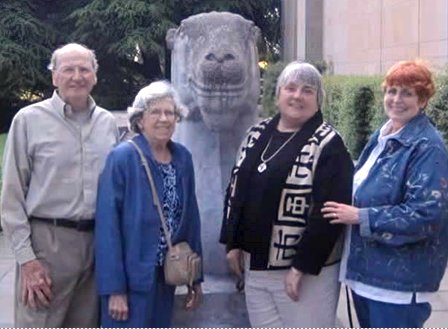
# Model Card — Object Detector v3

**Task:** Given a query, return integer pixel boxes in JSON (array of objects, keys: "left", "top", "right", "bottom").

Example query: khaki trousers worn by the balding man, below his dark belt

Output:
[{"left": 14, "top": 221, "right": 98, "bottom": 328}]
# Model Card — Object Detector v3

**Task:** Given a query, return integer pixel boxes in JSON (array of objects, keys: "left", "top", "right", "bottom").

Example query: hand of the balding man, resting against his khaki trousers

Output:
[{"left": 20, "top": 259, "right": 53, "bottom": 310}]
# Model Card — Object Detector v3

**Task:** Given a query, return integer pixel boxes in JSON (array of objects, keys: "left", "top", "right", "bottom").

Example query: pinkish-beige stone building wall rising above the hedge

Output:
[{"left": 322, "top": 0, "right": 448, "bottom": 74}]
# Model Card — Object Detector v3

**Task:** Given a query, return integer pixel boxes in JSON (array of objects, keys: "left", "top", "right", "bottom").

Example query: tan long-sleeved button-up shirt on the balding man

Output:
[{"left": 0, "top": 92, "right": 118, "bottom": 264}]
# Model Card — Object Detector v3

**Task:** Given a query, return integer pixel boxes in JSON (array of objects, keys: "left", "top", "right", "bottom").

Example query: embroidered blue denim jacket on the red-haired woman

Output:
[{"left": 347, "top": 114, "right": 448, "bottom": 292}]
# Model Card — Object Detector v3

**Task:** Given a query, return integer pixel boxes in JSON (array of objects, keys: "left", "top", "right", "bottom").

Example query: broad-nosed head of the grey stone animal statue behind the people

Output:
[{"left": 167, "top": 13, "right": 259, "bottom": 131}]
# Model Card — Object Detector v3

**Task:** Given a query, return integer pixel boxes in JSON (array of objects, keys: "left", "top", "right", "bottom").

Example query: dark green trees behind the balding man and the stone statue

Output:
[{"left": 0, "top": 0, "right": 281, "bottom": 123}]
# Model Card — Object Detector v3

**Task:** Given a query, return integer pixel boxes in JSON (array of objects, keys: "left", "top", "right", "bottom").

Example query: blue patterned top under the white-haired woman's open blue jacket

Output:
[{"left": 157, "top": 163, "right": 182, "bottom": 265}]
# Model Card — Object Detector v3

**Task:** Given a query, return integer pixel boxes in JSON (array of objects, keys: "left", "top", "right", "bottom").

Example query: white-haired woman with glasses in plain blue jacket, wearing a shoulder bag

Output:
[{"left": 95, "top": 81, "right": 202, "bottom": 328}]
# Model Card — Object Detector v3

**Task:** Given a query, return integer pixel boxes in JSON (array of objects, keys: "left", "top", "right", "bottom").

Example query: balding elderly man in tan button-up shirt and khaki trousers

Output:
[{"left": 1, "top": 43, "right": 118, "bottom": 327}]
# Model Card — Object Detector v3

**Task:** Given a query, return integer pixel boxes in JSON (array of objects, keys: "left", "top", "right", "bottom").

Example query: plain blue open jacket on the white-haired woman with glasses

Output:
[{"left": 95, "top": 135, "right": 202, "bottom": 295}]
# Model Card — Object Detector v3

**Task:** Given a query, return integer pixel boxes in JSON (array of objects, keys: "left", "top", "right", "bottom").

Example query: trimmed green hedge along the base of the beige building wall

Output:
[{"left": 262, "top": 63, "right": 448, "bottom": 159}]
